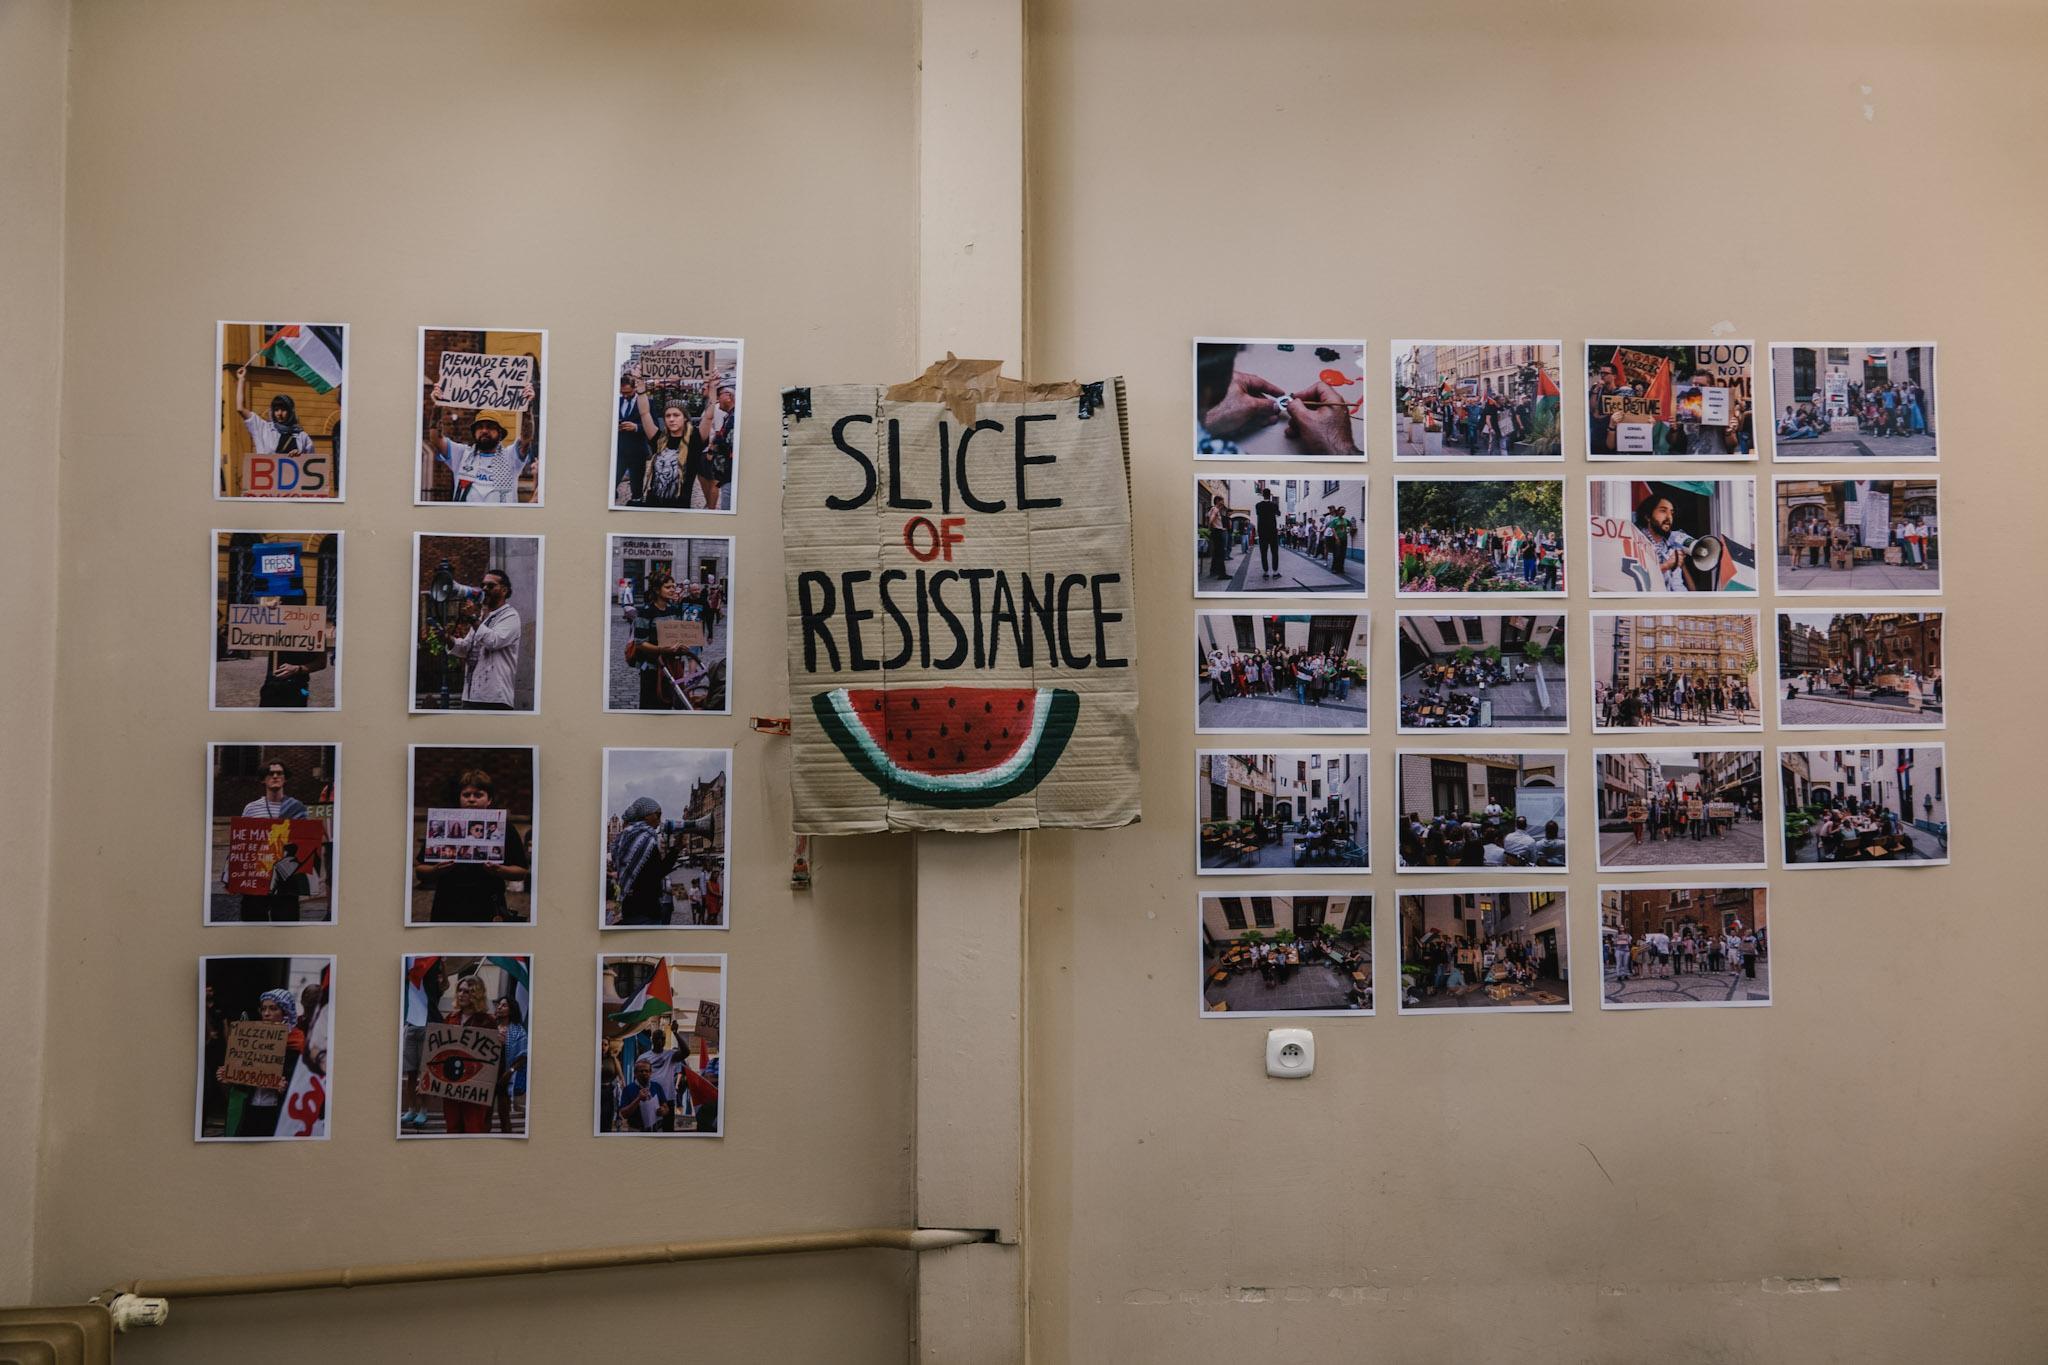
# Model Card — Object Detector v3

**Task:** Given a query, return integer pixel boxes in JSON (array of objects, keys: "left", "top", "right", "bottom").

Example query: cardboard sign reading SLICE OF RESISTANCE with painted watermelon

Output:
[{"left": 782, "top": 356, "right": 1139, "bottom": 835}]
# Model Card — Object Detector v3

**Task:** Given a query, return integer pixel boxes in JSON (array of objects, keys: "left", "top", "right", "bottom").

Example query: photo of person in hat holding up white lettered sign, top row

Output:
[{"left": 414, "top": 327, "right": 547, "bottom": 508}]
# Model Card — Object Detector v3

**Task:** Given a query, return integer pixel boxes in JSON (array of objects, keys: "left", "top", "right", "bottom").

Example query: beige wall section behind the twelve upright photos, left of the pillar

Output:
[{"left": 34, "top": 0, "right": 915, "bottom": 1361}]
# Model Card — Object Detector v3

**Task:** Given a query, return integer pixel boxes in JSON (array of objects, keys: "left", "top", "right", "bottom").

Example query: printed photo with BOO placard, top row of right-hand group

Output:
[{"left": 1585, "top": 342, "right": 1757, "bottom": 460}]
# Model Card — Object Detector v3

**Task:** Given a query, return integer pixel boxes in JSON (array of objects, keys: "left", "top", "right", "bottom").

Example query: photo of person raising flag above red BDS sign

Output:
[{"left": 213, "top": 321, "right": 348, "bottom": 501}]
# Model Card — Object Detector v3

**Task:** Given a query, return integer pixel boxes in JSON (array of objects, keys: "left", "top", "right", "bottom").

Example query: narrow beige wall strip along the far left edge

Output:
[{"left": 0, "top": 2, "right": 70, "bottom": 1304}]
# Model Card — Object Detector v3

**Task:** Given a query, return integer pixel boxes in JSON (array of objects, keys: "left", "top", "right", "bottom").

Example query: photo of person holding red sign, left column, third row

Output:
[{"left": 205, "top": 745, "right": 340, "bottom": 925}]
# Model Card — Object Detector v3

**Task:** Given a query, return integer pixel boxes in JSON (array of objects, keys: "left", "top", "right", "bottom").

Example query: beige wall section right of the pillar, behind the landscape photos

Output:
[{"left": 1028, "top": 0, "right": 2048, "bottom": 1363}]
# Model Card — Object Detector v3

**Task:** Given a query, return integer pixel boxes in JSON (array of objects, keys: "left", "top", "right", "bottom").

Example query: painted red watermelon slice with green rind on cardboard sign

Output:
[{"left": 811, "top": 688, "right": 1081, "bottom": 810}]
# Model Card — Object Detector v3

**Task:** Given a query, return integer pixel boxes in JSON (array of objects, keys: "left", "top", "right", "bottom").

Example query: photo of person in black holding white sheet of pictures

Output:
[{"left": 406, "top": 745, "right": 539, "bottom": 925}]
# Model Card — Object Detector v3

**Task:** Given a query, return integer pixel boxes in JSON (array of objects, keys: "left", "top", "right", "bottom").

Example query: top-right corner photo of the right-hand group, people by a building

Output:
[{"left": 1769, "top": 342, "right": 1939, "bottom": 460}]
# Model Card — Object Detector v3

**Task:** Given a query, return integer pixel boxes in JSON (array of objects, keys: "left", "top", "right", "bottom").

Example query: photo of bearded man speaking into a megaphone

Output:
[{"left": 1585, "top": 477, "right": 1757, "bottom": 598}]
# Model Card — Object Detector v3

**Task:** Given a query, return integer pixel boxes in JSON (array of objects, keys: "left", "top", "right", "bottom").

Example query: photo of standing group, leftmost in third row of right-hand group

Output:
[{"left": 1194, "top": 612, "right": 1372, "bottom": 735}]
